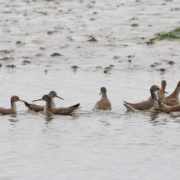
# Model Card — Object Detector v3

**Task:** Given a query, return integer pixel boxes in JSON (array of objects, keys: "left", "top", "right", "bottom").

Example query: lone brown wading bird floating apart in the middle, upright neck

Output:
[{"left": 95, "top": 87, "right": 112, "bottom": 110}]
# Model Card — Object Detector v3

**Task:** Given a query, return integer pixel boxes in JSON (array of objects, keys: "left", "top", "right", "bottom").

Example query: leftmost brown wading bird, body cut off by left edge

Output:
[{"left": 0, "top": 96, "right": 24, "bottom": 115}]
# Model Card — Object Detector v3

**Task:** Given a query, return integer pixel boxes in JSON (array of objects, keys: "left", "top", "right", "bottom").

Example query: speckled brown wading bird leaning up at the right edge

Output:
[{"left": 161, "top": 81, "right": 180, "bottom": 106}]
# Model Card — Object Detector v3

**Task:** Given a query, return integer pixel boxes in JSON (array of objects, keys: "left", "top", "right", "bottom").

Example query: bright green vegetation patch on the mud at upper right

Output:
[{"left": 150, "top": 27, "right": 180, "bottom": 41}]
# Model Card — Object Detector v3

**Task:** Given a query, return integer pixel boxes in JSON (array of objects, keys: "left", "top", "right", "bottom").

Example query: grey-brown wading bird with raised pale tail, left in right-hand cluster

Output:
[{"left": 124, "top": 85, "right": 160, "bottom": 111}]
